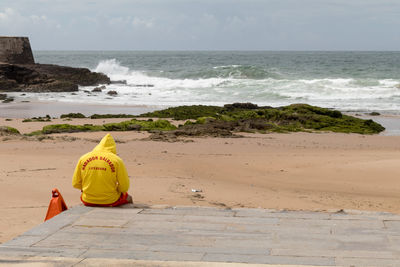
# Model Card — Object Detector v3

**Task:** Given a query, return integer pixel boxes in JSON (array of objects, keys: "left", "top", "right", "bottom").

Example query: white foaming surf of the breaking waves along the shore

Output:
[{"left": 8, "top": 59, "right": 400, "bottom": 112}]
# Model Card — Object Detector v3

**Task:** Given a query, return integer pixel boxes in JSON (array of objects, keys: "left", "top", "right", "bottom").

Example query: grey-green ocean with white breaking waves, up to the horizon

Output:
[{"left": 16, "top": 51, "right": 400, "bottom": 114}]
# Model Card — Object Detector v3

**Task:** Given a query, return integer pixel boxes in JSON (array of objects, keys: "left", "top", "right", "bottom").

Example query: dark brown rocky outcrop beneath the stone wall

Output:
[{"left": 0, "top": 63, "right": 110, "bottom": 92}]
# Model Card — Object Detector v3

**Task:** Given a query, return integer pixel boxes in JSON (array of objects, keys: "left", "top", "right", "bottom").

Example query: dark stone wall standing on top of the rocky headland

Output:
[{"left": 0, "top": 36, "right": 35, "bottom": 64}]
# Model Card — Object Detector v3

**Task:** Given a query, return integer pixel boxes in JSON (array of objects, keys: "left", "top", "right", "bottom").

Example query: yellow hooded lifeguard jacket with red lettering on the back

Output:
[{"left": 72, "top": 134, "right": 129, "bottom": 204}]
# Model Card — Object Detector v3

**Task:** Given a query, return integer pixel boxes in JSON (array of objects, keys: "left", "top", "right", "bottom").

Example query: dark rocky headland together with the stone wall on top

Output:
[{"left": 0, "top": 36, "right": 110, "bottom": 92}]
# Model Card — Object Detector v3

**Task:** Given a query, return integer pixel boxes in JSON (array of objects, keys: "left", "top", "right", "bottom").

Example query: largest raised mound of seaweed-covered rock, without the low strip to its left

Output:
[{"left": 141, "top": 103, "right": 385, "bottom": 134}]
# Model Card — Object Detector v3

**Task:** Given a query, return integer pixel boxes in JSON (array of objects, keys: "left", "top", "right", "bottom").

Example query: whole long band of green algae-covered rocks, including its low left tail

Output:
[{"left": 21, "top": 103, "right": 385, "bottom": 137}]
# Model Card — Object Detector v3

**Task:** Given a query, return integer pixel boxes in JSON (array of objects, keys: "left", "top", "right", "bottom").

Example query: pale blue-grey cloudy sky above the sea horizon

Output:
[{"left": 0, "top": 0, "right": 400, "bottom": 51}]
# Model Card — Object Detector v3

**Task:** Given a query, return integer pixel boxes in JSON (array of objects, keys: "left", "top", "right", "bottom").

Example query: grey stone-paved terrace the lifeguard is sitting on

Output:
[{"left": 0, "top": 205, "right": 400, "bottom": 266}]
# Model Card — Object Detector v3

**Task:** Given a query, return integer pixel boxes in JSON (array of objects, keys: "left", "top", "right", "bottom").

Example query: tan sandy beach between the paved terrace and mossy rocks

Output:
[{"left": 0, "top": 115, "right": 400, "bottom": 245}]
